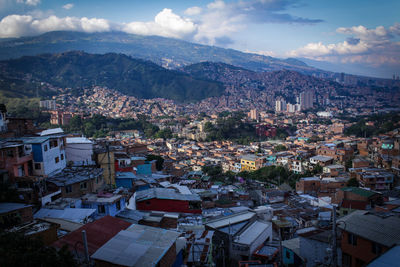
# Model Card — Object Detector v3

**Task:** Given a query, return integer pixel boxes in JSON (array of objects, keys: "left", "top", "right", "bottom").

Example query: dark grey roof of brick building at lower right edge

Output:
[{"left": 338, "top": 210, "right": 400, "bottom": 247}]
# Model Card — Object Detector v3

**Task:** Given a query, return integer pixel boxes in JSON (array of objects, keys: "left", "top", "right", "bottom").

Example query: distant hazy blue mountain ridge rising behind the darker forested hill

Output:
[{"left": 0, "top": 31, "right": 321, "bottom": 74}]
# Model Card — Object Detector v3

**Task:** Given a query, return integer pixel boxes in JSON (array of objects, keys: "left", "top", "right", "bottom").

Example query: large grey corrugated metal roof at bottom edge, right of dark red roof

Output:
[{"left": 92, "top": 224, "right": 180, "bottom": 266}]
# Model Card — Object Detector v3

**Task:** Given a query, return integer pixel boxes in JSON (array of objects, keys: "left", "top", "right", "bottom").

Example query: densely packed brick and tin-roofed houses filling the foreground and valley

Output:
[{"left": 0, "top": 98, "right": 400, "bottom": 266}]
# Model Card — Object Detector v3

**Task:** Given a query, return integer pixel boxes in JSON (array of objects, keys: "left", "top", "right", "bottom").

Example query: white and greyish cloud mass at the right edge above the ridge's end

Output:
[{"left": 288, "top": 23, "right": 400, "bottom": 66}]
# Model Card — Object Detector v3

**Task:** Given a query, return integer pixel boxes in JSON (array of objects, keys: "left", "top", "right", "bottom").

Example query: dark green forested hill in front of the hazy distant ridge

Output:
[{"left": 0, "top": 52, "right": 224, "bottom": 102}]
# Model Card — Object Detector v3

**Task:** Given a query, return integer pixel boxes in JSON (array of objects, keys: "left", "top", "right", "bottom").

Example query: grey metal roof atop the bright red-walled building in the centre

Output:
[{"left": 136, "top": 188, "right": 201, "bottom": 201}]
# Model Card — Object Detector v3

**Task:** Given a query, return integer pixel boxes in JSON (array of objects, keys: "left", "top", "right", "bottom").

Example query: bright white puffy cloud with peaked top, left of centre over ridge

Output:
[{"left": 122, "top": 8, "right": 197, "bottom": 38}]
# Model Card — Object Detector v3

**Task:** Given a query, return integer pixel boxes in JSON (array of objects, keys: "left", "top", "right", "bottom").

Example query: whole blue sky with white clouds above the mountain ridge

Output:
[{"left": 0, "top": 0, "right": 400, "bottom": 78}]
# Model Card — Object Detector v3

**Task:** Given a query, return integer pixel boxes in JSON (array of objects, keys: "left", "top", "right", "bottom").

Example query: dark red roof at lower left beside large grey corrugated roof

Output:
[{"left": 52, "top": 216, "right": 131, "bottom": 255}]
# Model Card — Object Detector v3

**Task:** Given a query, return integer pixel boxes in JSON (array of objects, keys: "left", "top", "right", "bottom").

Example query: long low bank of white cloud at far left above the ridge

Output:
[{"left": 0, "top": 15, "right": 111, "bottom": 37}]
